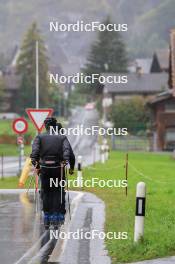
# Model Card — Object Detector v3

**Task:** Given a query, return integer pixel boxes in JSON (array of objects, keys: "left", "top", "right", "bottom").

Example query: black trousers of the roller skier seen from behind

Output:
[{"left": 40, "top": 167, "right": 66, "bottom": 214}]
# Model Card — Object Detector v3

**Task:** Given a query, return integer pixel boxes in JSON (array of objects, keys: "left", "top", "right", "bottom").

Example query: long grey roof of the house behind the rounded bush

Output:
[{"left": 103, "top": 73, "right": 168, "bottom": 94}]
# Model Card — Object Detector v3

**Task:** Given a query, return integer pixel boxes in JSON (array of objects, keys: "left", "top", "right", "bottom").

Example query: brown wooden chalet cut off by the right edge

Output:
[{"left": 149, "top": 29, "right": 175, "bottom": 151}]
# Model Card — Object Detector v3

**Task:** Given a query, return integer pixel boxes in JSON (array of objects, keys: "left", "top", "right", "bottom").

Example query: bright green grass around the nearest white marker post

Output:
[{"left": 81, "top": 152, "right": 175, "bottom": 264}]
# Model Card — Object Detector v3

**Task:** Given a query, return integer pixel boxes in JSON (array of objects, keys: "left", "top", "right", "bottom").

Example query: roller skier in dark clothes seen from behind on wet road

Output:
[{"left": 30, "top": 117, "right": 75, "bottom": 228}]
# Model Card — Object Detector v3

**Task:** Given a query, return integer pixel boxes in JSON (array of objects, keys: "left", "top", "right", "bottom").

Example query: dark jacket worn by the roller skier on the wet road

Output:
[{"left": 30, "top": 132, "right": 75, "bottom": 169}]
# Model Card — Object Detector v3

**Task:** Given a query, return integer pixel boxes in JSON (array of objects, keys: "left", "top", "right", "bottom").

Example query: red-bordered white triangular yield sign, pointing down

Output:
[{"left": 26, "top": 108, "right": 53, "bottom": 132}]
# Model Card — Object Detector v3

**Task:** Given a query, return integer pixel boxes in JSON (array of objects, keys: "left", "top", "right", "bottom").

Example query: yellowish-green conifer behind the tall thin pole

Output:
[{"left": 17, "top": 23, "right": 49, "bottom": 112}]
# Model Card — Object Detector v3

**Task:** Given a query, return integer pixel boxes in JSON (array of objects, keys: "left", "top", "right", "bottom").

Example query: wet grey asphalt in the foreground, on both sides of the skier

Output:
[{"left": 0, "top": 190, "right": 111, "bottom": 264}]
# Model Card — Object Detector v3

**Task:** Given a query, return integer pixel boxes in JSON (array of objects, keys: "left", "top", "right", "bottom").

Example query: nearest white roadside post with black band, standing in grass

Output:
[{"left": 134, "top": 182, "right": 146, "bottom": 242}]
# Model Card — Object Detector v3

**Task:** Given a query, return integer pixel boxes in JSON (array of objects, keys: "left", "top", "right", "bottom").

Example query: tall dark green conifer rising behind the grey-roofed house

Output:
[{"left": 83, "top": 18, "right": 127, "bottom": 93}]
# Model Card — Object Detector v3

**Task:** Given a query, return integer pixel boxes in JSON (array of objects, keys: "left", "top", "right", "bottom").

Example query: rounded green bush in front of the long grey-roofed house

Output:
[{"left": 111, "top": 97, "right": 150, "bottom": 134}]
